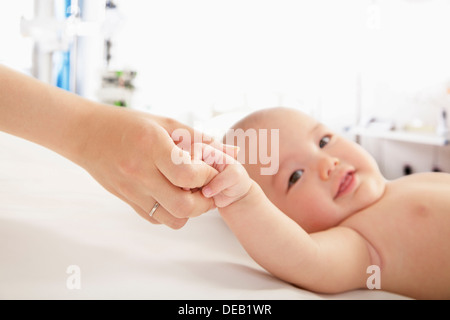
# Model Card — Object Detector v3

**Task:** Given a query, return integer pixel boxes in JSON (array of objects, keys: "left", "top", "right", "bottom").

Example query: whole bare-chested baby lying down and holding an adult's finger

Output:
[{"left": 202, "top": 108, "right": 450, "bottom": 299}]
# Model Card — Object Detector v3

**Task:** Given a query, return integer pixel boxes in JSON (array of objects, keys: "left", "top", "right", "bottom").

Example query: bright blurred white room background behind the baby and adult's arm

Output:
[{"left": 0, "top": 0, "right": 450, "bottom": 179}]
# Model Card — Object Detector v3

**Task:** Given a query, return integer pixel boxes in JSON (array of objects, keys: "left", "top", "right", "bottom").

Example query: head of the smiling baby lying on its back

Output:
[{"left": 225, "top": 108, "right": 385, "bottom": 232}]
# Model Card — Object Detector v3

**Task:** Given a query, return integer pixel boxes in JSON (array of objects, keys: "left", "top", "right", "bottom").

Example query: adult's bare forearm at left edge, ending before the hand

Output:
[{"left": 0, "top": 65, "right": 96, "bottom": 158}]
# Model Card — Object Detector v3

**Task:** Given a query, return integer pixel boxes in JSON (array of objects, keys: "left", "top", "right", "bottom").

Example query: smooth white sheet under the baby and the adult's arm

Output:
[{"left": 0, "top": 133, "right": 405, "bottom": 300}]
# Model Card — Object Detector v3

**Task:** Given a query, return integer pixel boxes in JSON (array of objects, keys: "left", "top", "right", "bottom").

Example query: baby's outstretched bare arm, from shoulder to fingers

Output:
[{"left": 202, "top": 144, "right": 371, "bottom": 293}]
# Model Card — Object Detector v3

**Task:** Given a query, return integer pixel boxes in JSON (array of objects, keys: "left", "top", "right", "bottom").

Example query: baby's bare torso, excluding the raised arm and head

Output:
[{"left": 343, "top": 173, "right": 450, "bottom": 297}]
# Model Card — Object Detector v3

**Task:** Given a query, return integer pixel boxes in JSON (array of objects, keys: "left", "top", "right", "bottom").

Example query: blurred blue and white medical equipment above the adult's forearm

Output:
[{"left": 21, "top": 0, "right": 136, "bottom": 106}]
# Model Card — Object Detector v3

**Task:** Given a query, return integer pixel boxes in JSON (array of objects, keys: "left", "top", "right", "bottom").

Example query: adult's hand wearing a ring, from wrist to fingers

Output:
[{"left": 76, "top": 106, "right": 236, "bottom": 229}]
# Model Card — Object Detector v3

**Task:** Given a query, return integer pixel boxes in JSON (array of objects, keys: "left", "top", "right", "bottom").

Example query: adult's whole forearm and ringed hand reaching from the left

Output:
[{"left": 0, "top": 65, "right": 234, "bottom": 229}]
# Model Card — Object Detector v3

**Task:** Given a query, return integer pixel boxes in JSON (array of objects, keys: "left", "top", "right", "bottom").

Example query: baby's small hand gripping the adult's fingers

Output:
[{"left": 194, "top": 144, "right": 252, "bottom": 208}]
